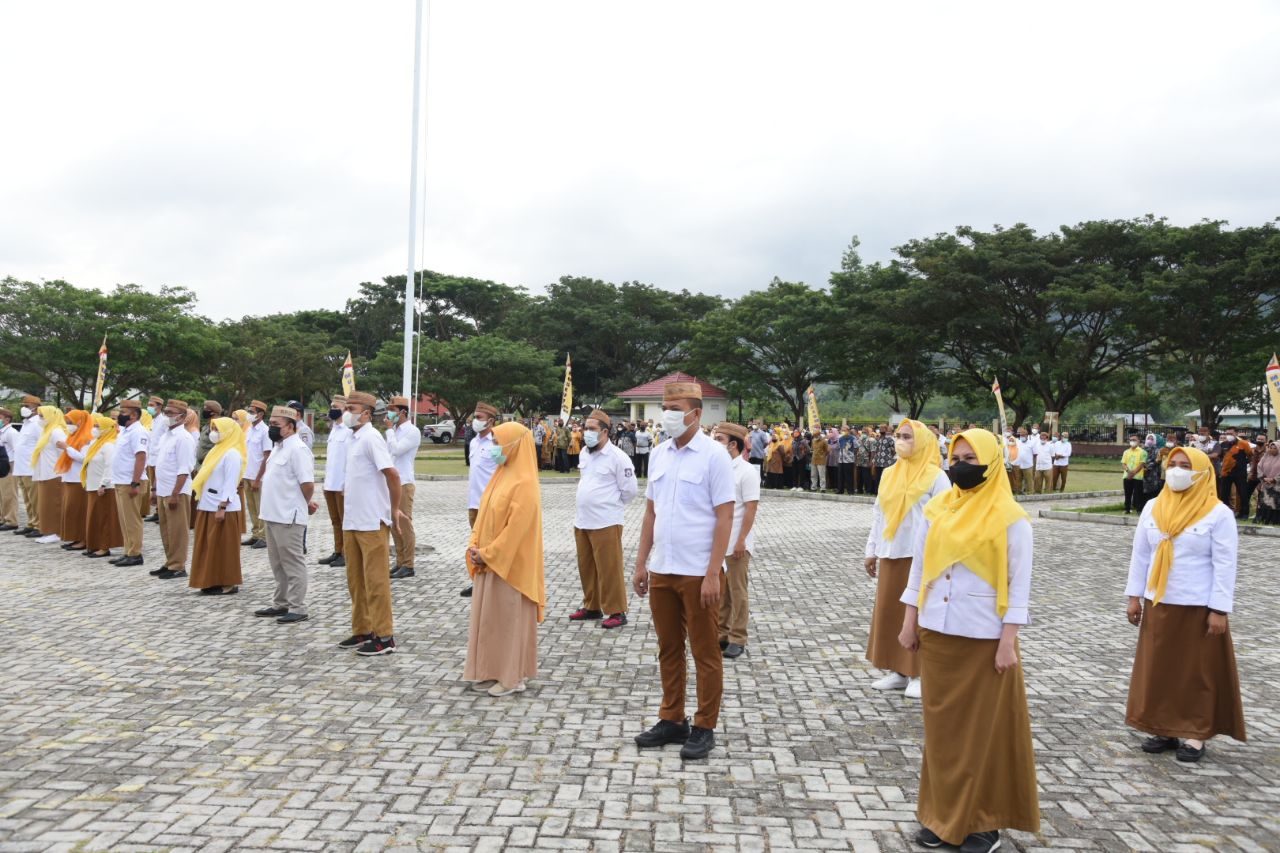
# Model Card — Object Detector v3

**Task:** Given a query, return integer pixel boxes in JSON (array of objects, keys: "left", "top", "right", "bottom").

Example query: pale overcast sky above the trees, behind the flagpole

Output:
[{"left": 0, "top": 0, "right": 1280, "bottom": 318}]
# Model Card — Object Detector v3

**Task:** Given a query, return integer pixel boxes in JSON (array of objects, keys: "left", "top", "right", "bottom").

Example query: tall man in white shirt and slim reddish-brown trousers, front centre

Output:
[{"left": 631, "top": 382, "right": 733, "bottom": 758}]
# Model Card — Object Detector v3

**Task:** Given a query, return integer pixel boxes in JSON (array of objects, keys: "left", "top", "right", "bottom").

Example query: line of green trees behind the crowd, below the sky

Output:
[{"left": 0, "top": 216, "right": 1280, "bottom": 424}]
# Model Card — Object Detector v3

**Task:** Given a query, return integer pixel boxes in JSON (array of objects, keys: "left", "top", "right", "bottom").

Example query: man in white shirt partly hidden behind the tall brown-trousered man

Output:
[{"left": 716, "top": 423, "right": 757, "bottom": 658}]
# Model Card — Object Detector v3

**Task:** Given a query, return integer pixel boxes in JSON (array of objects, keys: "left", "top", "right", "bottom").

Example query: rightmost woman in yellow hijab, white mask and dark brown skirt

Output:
[{"left": 1125, "top": 447, "right": 1244, "bottom": 762}]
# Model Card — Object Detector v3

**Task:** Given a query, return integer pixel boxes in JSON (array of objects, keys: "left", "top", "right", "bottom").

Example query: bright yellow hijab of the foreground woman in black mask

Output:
[{"left": 921, "top": 429, "right": 1027, "bottom": 617}]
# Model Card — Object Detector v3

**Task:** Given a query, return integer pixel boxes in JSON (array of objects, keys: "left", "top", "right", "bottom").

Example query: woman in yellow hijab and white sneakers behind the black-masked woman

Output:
[{"left": 860, "top": 420, "right": 951, "bottom": 699}]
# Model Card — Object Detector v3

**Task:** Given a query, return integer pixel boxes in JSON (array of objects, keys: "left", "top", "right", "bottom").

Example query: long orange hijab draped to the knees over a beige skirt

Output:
[{"left": 467, "top": 421, "right": 547, "bottom": 621}]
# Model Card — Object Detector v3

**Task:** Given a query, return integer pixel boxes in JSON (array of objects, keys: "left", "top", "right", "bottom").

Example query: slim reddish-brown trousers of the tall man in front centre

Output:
[{"left": 649, "top": 573, "right": 724, "bottom": 729}]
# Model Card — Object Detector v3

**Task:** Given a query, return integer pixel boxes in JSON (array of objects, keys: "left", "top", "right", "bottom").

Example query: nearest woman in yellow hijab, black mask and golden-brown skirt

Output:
[{"left": 888, "top": 429, "right": 1039, "bottom": 850}]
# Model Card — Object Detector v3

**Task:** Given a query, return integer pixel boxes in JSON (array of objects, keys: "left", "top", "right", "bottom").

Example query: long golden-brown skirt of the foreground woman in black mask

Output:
[{"left": 915, "top": 629, "right": 1039, "bottom": 845}]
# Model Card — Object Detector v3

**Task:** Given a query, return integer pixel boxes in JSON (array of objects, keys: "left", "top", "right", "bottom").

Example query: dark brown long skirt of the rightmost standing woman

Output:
[{"left": 1124, "top": 601, "right": 1244, "bottom": 742}]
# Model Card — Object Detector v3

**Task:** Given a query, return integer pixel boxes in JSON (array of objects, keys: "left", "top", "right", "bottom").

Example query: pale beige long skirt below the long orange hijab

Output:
[{"left": 462, "top": 571, "right": 538, "bottom": 688}]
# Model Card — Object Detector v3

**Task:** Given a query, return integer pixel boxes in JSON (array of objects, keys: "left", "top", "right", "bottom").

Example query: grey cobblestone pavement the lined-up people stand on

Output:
[{"left": 0, "top": 482, "right": 1280, "bottom": 853}]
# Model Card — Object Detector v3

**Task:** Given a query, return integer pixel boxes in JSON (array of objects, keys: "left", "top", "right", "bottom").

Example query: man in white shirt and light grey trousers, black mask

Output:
[{"left": 253, "top": 406, "right": 319, "bottom": 625}]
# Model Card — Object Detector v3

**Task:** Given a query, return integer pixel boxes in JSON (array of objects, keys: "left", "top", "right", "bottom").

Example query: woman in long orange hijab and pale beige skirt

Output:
[{"left": 462, "top": 421, "right": 547, "bottom": 697}]
